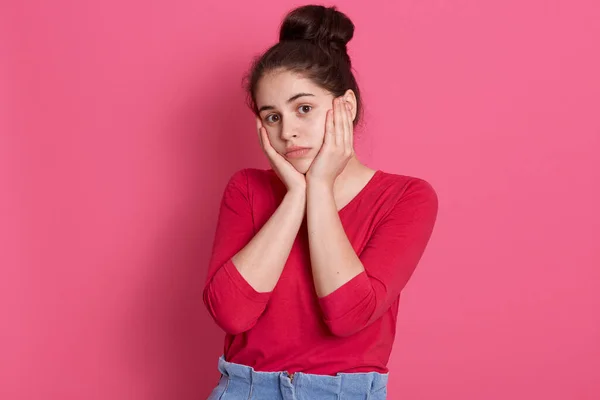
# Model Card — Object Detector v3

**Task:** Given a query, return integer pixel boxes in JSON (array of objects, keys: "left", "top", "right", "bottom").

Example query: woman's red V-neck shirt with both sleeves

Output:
[{"left": 203, "top": 168, "right": 438, "bottom": 375}]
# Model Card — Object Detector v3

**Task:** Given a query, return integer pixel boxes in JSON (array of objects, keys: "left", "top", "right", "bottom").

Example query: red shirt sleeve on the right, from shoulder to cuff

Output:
[{"left": 319, "top": 178, "right": 438, "bottom": 336}]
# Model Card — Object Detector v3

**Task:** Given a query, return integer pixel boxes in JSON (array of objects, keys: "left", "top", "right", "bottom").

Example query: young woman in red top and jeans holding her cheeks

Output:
[{"left": 203, "top": 6, "right": 437, "bottom": 400}]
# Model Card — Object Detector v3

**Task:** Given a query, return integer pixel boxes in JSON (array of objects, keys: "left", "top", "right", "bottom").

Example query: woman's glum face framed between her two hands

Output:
[{"left": 256, "top": 71, "right": 351, "bottom": 174}]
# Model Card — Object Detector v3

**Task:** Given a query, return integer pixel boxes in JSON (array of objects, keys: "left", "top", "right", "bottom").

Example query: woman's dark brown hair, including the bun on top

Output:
[{"left": 244, "top": 5, "right": 362, "bottom": 126}]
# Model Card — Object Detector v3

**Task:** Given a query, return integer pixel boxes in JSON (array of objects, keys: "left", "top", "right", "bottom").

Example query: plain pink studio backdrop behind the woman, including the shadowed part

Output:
[{"left": 0, "top": 0, "right": 600, "bottom": 400}]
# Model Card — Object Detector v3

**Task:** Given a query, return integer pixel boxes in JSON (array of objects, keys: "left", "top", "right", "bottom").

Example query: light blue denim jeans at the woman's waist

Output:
[{"left": 207, "top": 356, "right": 388, "bottom": 400}]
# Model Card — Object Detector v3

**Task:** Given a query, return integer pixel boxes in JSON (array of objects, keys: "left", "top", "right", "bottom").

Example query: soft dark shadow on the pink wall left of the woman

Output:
[{"left": 132, "top": 56, "right": 261, "bottom": 400}]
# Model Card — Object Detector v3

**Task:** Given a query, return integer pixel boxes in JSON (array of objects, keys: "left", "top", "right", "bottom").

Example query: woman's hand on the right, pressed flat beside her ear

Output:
[{"left": 306, "top": 97, "right": 354, "bottom": 187}]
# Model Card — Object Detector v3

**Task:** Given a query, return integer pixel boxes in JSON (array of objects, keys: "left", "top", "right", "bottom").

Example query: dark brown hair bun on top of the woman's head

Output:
[{"left": 279, "top": 5, "right": 354, "bottom": 51}]
